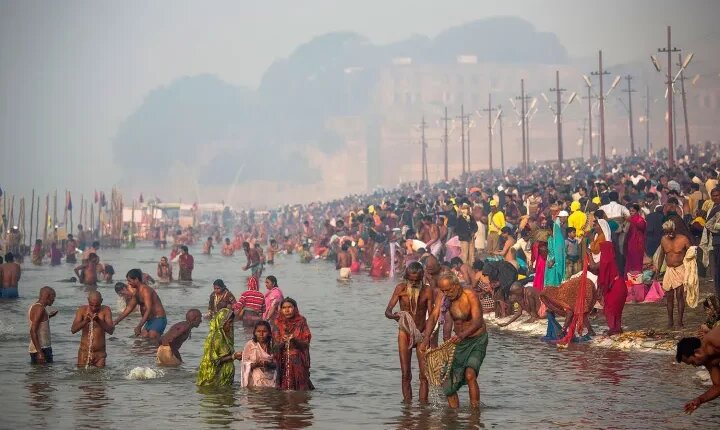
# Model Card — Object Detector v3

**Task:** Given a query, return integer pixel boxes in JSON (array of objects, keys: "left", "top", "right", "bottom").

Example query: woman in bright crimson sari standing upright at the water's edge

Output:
[{"left": 595, "top": 219, "right": 627, "bottom": 336}]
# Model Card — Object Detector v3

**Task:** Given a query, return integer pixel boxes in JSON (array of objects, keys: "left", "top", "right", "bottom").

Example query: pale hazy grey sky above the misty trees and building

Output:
[{"left": 0, "top": 0, "right": 720, "bottom": 200}]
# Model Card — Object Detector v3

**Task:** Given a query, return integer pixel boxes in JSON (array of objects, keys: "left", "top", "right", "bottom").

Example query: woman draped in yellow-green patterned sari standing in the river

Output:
[{"left": 195, "top": 308, "right": 235, "bottom": 387}]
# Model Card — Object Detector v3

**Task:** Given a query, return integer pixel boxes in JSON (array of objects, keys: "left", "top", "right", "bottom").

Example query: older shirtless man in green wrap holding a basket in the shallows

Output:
[{"left": 419, "top": 273, "right": 488, "bottom": 409}]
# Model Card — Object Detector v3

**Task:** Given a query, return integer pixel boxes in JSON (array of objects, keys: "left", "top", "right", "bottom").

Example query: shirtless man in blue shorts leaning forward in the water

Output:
[{"left": 115, "top": 269, "right": 167, "bottom": 340}]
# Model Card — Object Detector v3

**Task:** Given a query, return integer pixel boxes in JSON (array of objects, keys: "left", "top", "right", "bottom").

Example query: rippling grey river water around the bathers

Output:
[{"left": 0, "top": 247, "right": 720, "bottom": 429}]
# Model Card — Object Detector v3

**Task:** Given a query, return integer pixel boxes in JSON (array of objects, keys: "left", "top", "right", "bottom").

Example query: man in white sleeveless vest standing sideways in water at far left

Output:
[{"left": 28, "top": 287, "right": 57, "bottom": 364}]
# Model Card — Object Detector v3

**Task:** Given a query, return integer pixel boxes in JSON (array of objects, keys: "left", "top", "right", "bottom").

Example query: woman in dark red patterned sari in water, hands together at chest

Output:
[{"left": 274, "top": 297, "right": 315, "bottom": 391}]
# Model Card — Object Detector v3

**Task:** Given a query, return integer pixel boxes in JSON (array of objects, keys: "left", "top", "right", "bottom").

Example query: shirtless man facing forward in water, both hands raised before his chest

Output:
[{"left": 70, "top": 291, "right": 115, "bottom": 368}]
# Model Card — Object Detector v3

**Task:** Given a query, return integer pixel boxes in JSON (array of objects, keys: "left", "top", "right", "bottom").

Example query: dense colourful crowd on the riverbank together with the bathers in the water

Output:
[{"left": 8, "top": 144, "right": 720, "bottom": 411}]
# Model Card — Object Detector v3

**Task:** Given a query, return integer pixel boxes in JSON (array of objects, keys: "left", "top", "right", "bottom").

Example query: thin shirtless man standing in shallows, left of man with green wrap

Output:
[{"left": 385, "top": 262, "right": 435, "bottom": 403}]
